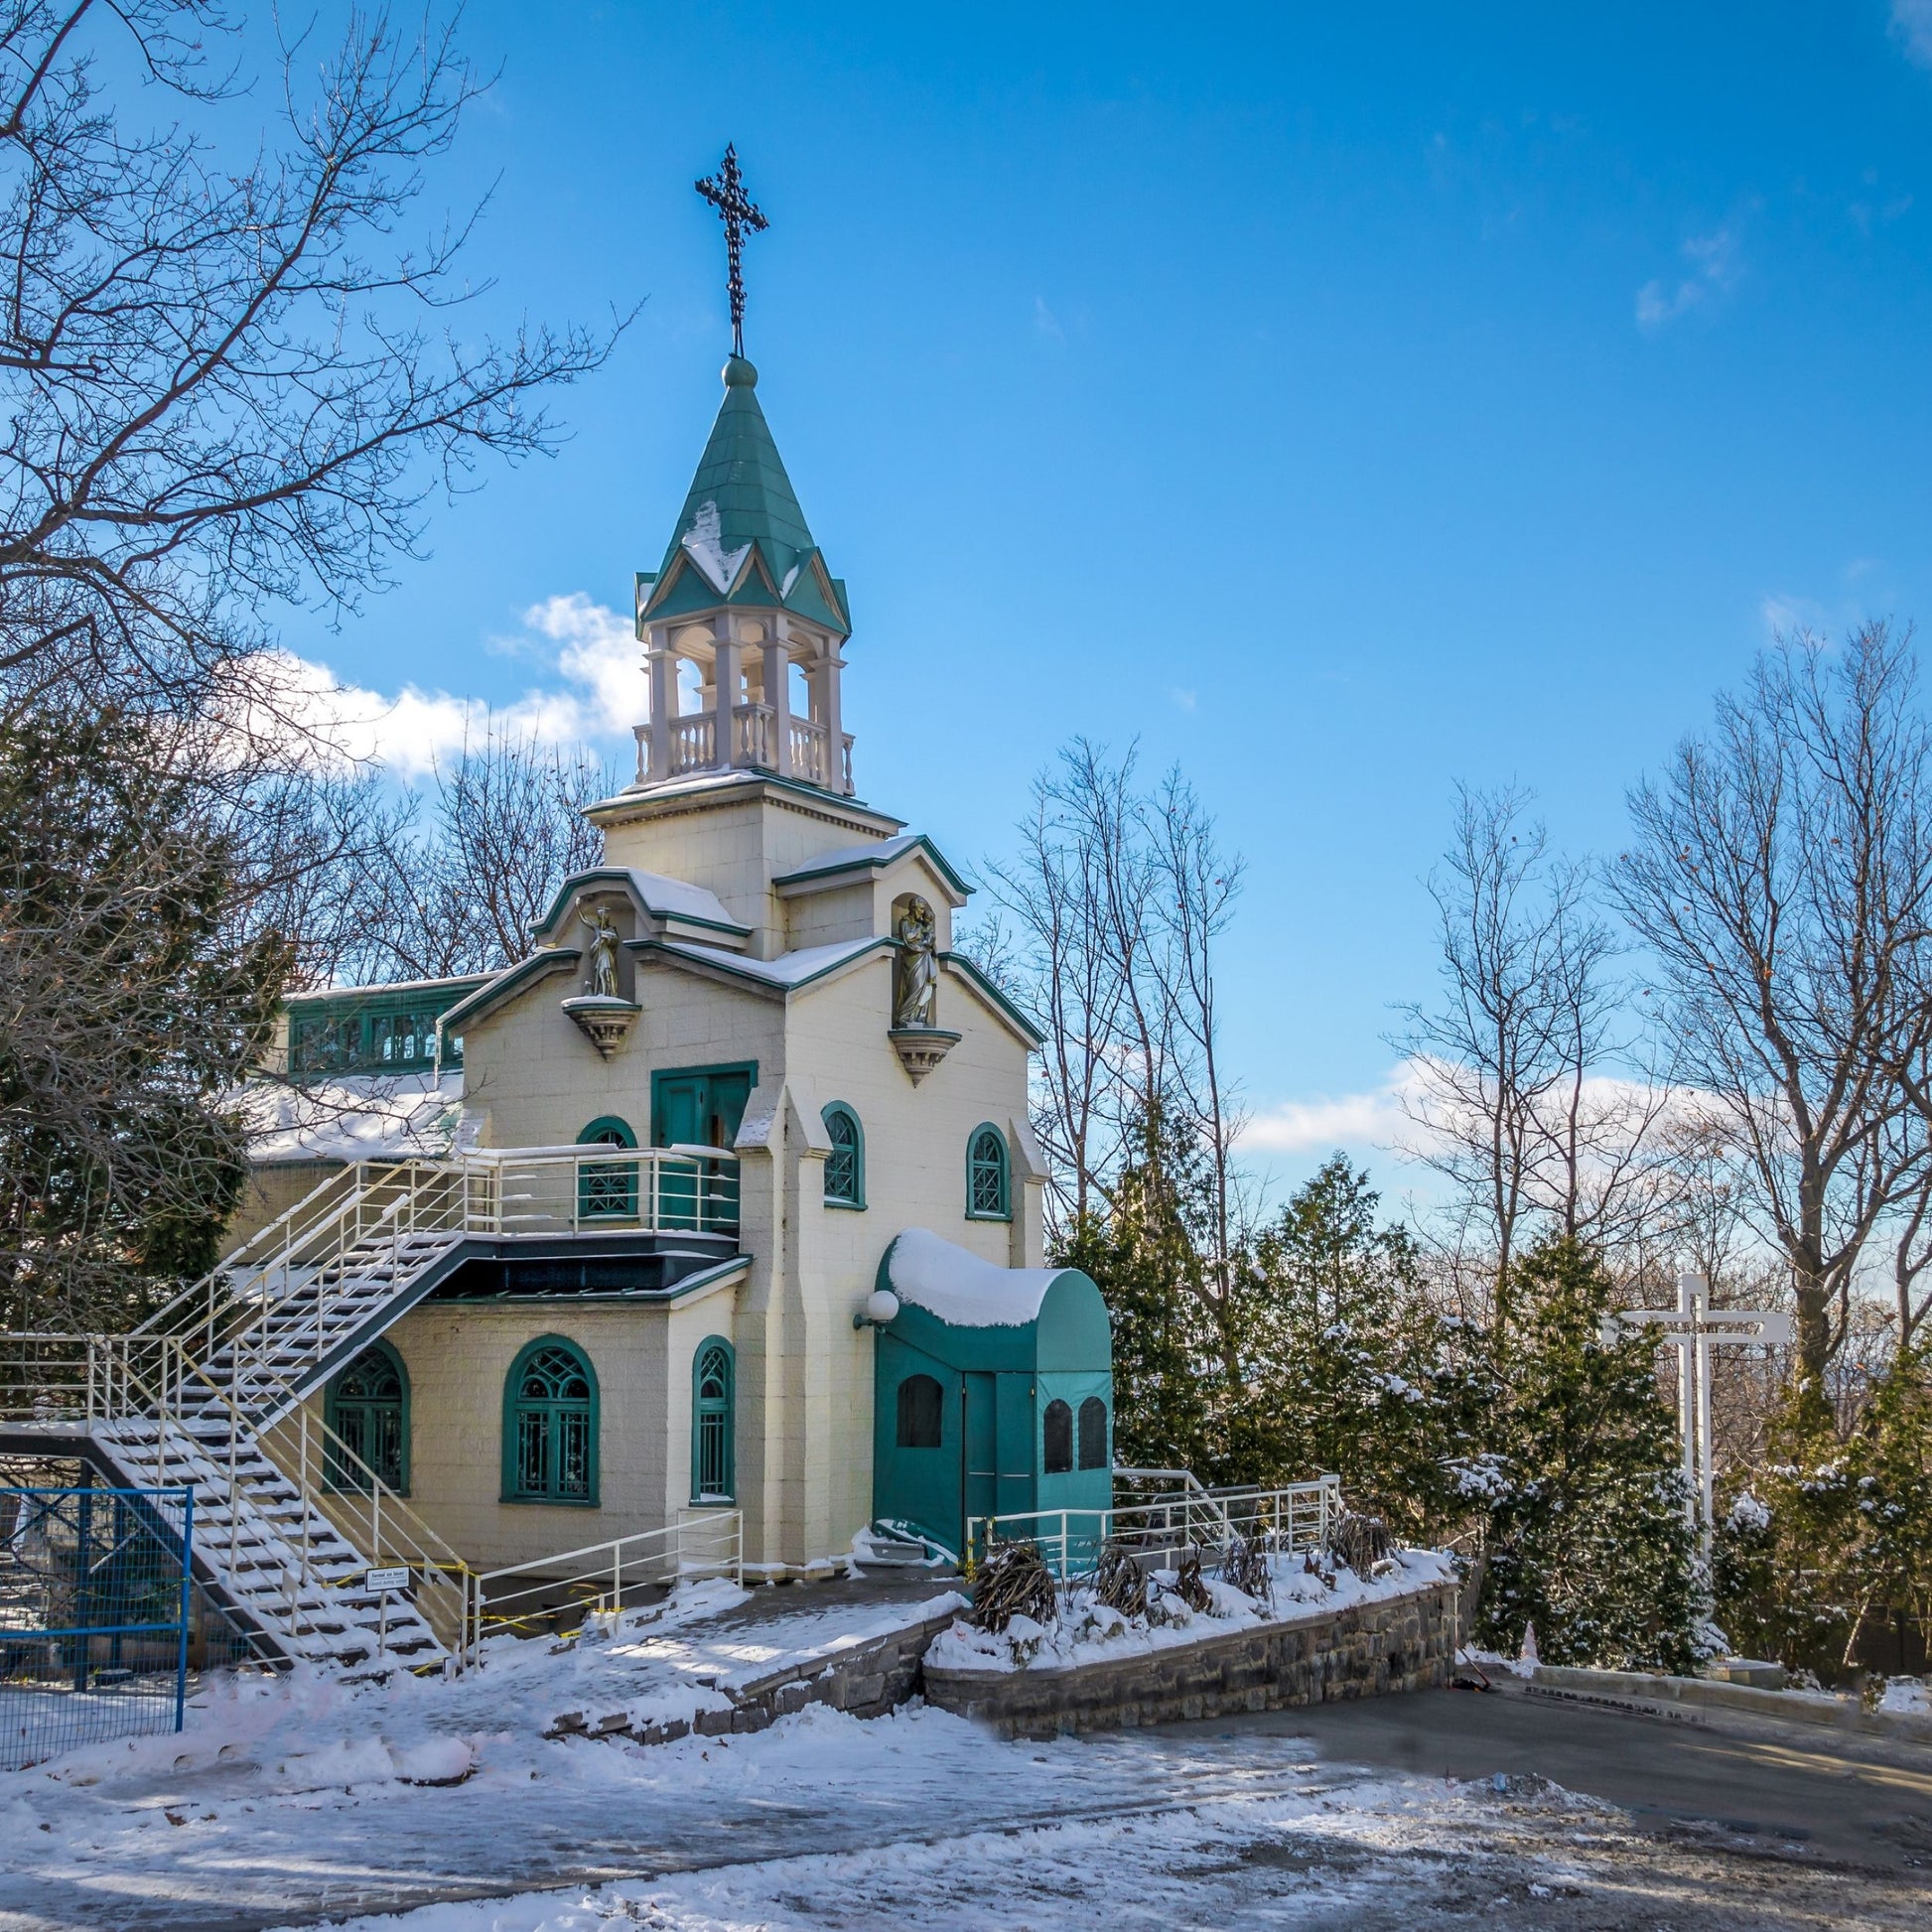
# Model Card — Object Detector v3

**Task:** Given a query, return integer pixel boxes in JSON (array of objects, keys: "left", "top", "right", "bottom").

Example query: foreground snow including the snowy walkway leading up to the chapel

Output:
[{"left": 0, "top": 1579, "right": 1909, "bottom": 1932}]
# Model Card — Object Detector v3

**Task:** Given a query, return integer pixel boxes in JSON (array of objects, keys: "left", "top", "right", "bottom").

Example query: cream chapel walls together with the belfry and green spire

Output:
[{"left": 266, "top": 357, "right": 1043, "bottom": 1573}]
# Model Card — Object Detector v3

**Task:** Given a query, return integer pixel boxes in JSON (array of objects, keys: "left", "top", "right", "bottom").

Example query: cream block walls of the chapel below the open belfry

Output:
[{"left": 399, "top": 772, "right": 1043, "bottom": 1573}]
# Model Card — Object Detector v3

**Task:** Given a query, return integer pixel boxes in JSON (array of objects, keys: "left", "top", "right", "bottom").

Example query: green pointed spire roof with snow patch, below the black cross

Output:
[{"left": 639, "top": 355, "right": 852, "bottom": 633}]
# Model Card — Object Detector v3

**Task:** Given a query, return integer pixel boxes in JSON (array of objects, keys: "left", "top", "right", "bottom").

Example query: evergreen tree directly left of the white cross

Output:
[{"left": 1478, "top": 1240, "right": 1699, "bottom": 1671}]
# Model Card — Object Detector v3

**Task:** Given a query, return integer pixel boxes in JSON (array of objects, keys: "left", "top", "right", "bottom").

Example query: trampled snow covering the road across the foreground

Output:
[{"left": 0, "top": 1644, "right": 1584, "bottom": 1932}]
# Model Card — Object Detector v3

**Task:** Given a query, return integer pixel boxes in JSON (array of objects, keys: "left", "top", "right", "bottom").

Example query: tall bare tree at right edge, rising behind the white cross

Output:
[{"left": 1613, "top": 624, "right": 1932, "bottom": 1393}]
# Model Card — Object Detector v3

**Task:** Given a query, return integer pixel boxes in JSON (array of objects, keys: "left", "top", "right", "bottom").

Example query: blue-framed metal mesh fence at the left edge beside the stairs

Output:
[{"left": 0, "top": 1487, "right": 196, "bottom": 1770}]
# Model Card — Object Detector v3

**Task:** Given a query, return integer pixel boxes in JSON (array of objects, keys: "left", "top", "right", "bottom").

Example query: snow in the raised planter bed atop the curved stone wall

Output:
[{"left": 925, "top": 1550, "right": 1456, "bottom": 1671}]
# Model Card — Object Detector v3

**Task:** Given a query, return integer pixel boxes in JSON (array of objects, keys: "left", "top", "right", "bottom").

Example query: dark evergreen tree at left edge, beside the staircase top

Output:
[{"left": 0, "top": 711, "right": 290, "bottom": 1329}]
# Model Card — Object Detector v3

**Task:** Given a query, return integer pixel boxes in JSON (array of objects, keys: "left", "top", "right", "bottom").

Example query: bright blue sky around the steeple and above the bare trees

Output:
[{"left": 286, "top": 0, "right": 1932, "bottom": 1184}]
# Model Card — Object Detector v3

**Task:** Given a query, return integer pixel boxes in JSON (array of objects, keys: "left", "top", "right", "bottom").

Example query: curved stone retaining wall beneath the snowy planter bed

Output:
[{"left": 923, "top": 1585, "right": 1458, "bottom": 1736}]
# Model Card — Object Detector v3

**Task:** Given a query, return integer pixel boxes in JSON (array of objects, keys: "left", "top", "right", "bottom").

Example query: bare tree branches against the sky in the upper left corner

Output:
[{"left": 0, "top": 0, "right": 611, "bottom": 715}]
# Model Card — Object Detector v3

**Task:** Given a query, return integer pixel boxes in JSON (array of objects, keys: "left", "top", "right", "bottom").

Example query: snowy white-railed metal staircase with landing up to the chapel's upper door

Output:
[{"left": 0, "top": 1148, "right": 736, "bottom": 1667}]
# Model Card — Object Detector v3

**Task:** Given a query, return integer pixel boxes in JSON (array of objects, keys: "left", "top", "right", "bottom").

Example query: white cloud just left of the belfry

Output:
[{"left": 245, "top": 591, "right": 647, "bottom": 780}]
